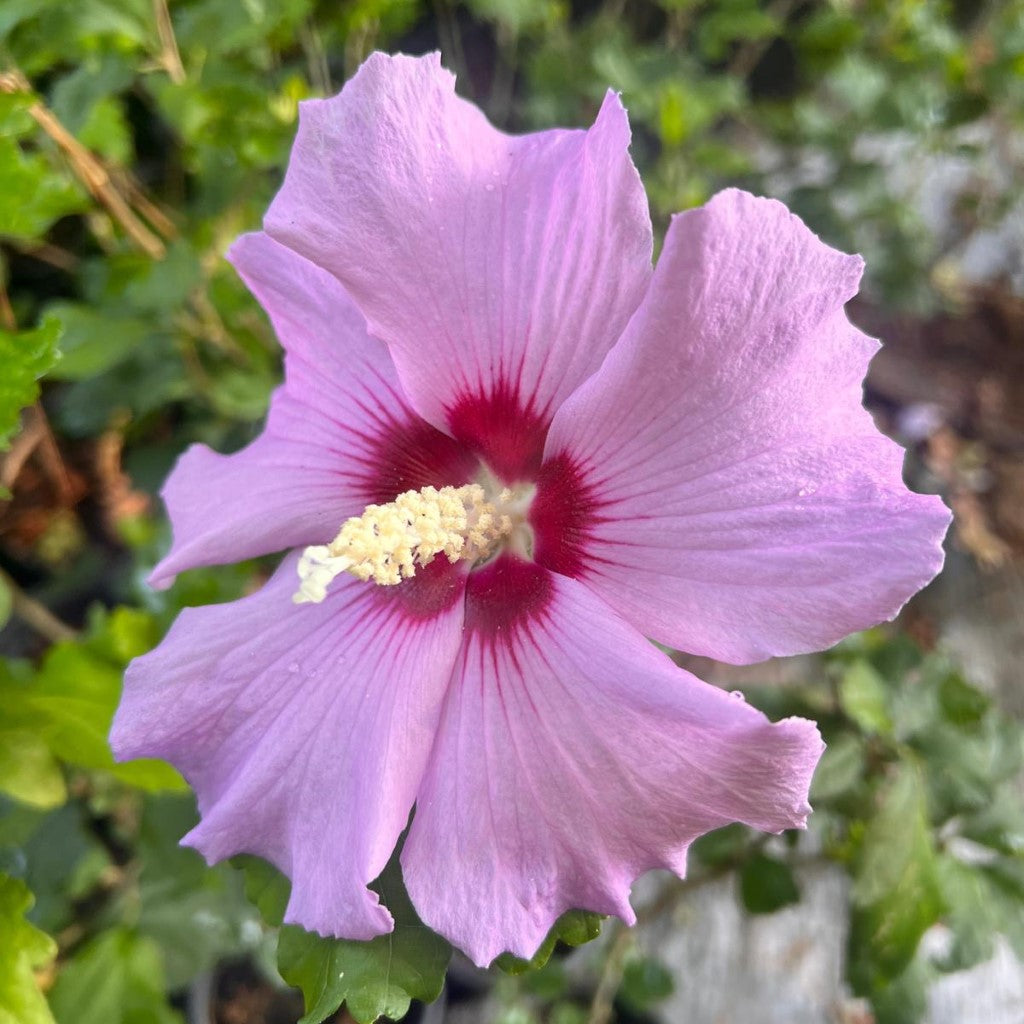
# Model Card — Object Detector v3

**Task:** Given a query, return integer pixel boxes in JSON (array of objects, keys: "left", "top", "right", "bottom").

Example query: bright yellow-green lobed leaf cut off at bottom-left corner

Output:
[{"left": 0, "top": 874, "right": 57, "bottom": 1024}]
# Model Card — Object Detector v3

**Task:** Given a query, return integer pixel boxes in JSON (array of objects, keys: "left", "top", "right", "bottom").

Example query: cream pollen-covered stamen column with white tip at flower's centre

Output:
[{"left": 293, "top": 483, "right": 512, "bottom": 604}]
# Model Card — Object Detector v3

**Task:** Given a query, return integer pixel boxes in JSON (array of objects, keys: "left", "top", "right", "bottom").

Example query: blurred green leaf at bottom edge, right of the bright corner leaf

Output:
[{"left": 50, "top": 928, "right": 183, "bottom": 1024}]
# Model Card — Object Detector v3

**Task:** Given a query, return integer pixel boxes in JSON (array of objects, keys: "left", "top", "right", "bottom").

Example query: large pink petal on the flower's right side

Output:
[{"left": 535, "top": 190, "right": 949, "bottom": 663}]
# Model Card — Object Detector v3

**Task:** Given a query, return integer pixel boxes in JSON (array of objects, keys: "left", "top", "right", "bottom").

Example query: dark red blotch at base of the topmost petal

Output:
[{"left": 447, "top": 382, "right": 551, "bottom": 483}]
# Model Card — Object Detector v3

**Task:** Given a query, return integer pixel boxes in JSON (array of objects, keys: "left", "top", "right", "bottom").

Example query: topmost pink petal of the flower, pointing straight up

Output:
[{"left": 265, "top": 53, "right": 651, "bottom": 475}]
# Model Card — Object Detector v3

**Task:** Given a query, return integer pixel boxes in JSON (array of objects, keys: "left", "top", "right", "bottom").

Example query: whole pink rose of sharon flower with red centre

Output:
[{"left": 113, "top": 54, "right": 948, "bottom": 965}]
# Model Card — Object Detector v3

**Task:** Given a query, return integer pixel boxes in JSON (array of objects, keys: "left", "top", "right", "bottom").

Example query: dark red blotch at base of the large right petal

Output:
[{"left": 529, "top": 452, "right": 605, "bottom": 579}]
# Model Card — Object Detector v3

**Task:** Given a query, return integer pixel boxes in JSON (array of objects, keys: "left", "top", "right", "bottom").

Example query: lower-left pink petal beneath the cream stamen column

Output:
[{"left": 111, "top": 556, "right": 464, "bottom": 939}]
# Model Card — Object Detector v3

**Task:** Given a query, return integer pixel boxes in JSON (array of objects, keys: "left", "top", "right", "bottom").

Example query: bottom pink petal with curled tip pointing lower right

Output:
[{"left": 402, "top": 562, "right": 823, "bottom": 966}]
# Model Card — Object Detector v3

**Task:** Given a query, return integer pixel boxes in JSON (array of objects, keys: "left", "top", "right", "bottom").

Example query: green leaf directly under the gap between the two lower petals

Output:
[{"left": 278, "top": 857, "right": 452, "bottom": 1024}]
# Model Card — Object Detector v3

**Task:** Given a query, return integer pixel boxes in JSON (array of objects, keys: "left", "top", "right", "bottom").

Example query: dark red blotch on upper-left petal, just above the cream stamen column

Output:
[{"left": 366, "top": 414, "right": 479, "bottom": 504}]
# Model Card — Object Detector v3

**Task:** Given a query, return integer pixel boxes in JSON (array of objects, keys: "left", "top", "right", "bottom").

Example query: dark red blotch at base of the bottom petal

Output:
[{"left": 466, "top": 555, "right": 552, "bottom": 641}]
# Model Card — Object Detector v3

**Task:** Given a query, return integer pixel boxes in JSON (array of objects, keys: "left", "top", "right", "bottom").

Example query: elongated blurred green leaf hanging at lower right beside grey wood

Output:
[{"left": 850, "top": 763, "right": 944, "bottom": 995}]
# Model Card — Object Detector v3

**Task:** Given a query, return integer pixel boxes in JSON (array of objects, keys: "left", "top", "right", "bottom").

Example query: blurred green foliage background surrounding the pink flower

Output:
[{"left": 0, "top": 0, "right": 1024, "bottom": 1024}]
